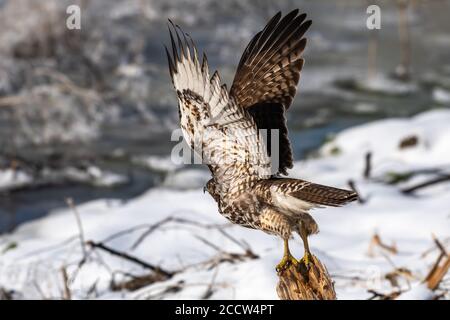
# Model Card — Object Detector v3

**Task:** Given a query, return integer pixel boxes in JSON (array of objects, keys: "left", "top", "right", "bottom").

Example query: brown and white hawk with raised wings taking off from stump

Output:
[{"left": 166, "top": 10, "right": 357, "bottom": 271}]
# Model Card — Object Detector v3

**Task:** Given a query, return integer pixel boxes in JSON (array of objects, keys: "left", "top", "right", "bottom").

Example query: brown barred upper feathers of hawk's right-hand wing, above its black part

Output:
[{"left": 230, "top": 10, "right": 311, "bottom": 109}]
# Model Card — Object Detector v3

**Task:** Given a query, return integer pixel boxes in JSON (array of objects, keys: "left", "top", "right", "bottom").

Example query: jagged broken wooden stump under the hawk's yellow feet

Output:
[{"left": 277, "top": 255, "right": 336, "bottom": 300}]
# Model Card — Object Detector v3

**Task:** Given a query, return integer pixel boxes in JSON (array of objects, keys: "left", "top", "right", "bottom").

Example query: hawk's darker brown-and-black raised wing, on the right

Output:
[{"left": 230, "top": 10, "right": 311, "bottom": 174}]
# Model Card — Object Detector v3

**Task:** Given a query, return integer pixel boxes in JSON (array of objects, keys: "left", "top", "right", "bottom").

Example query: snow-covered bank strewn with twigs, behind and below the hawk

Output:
[{"left": 0, "top": 110, "right": 450, "bottom": 299}]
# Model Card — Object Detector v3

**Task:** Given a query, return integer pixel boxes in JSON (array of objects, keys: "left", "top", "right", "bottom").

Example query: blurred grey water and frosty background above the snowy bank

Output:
[{"left": 0, "top": 0, "right": 450, "bottom": 233}]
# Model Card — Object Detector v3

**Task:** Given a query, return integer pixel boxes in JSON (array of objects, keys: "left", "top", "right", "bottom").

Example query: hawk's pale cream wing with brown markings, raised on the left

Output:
[{"left": 166, "top": 23, "right": 271, "bottom": 192}]
